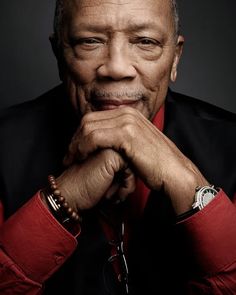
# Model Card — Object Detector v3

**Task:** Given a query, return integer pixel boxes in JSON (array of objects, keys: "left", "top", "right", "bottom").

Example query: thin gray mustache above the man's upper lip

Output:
[{"left": 90, "top": 89, "right": 148, "bottom": 100}]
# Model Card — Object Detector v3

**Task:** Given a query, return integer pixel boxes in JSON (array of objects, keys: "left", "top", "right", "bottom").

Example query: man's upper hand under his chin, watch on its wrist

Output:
[{"left": 65, "top": 107, "right": 208, "bottom": 214}]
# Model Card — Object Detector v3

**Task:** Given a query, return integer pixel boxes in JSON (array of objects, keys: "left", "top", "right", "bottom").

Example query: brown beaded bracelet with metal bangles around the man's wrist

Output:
[{"left": 43, "top": 175, "right": 81, "bottom": 227}]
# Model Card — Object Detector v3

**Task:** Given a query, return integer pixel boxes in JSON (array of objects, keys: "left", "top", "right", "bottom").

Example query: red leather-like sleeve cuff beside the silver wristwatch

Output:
[{"left": 177, "top": 190, "right": 236, "bottom": 295}]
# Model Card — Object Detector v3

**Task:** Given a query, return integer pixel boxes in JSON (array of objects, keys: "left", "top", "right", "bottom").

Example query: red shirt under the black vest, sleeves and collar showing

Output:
[{"left": 0, "top": 108, "right": 236, "bottom": 295}]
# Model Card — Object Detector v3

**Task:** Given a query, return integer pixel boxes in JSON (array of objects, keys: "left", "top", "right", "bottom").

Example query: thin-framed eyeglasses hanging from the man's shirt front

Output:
[{"left": 103, "top": 222, "right": 129, "bottom": 295}]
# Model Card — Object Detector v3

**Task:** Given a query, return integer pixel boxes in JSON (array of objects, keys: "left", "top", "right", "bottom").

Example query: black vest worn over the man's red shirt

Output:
[{"left": 0, "top": 86, "right": 236, "bottom": 295}]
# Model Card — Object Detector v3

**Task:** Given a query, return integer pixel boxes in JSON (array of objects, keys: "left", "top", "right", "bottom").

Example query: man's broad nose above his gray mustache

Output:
[{"left": 97, "top": 42, "right": 137, "bottom": 81}]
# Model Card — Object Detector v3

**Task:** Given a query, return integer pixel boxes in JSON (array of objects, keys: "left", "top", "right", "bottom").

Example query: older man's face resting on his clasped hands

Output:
[{"left": 56, "top": 0, "right": 183, "bottom": 119}]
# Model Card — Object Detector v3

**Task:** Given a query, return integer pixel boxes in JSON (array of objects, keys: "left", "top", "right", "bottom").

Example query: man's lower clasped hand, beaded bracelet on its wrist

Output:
[{"left": 57, "top": 149, "right": 135, "bottom": 210}]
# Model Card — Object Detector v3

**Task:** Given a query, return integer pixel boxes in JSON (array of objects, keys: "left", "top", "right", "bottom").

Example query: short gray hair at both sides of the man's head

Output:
[{"left": 53, "top": 0, "right": 180, "bottom": 43}]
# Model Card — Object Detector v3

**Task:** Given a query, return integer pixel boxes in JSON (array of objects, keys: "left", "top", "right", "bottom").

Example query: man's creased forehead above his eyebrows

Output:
[{"left": 65, "top": 0, "right": 173, "bottom": 34}]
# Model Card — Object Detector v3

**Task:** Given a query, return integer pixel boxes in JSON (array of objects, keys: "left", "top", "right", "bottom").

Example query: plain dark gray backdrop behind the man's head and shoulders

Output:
[{"left": 0, "top": 0, "right": 236, "bottom": 112}]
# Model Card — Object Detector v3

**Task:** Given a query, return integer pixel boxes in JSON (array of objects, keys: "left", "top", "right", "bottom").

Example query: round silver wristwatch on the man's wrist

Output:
[{"left": 192, "top": 185, "right": 219, "bottom": 210}]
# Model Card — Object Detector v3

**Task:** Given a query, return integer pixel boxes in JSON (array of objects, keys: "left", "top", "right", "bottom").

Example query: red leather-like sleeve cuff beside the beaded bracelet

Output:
[{"left": 0, "top": 192, "right": 77, "bottom": 294}]
